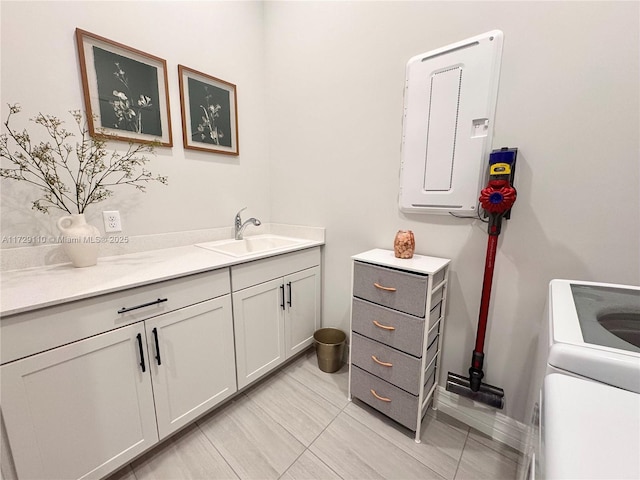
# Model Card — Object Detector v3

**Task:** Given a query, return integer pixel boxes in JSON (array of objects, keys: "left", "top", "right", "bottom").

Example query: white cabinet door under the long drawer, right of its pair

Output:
[{"left": 146, "top": 295, "right": 237, "bottom": 439}]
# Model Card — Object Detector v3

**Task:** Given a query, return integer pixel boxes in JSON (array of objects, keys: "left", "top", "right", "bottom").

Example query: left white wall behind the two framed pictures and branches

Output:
[{"left": 0, "top": 1, "right": 270, "bottom": 240}]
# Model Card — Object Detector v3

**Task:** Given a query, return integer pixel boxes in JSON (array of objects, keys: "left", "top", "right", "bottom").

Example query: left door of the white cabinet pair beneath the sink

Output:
[{"left": 233, "top": 279, "right": 285, "bottom": 388}]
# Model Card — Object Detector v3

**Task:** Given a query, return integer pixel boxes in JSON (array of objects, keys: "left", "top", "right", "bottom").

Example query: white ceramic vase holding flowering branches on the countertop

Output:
[{"left": 58, "top": 213, "right": 100, "bottom": 267}]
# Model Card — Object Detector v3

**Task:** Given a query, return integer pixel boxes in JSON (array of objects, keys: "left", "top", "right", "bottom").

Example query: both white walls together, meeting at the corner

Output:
[{"left": 0, "top": 1, "right": 640, "bottom": 421}]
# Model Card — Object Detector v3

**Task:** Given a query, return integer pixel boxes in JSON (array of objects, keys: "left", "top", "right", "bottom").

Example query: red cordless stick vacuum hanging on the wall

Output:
[{"left": 447, "top": 148, "right": 518, "bottom": 408}]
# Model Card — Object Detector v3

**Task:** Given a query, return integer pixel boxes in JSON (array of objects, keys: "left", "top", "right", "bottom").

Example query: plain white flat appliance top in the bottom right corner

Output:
[{"left": 541, "top": 373, "right": 640, "bottom": 479}]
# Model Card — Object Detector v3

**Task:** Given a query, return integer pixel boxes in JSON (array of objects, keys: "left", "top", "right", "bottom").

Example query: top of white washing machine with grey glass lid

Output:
[{"left": 548, "top": 280, "right": 640, "bottom": 393}]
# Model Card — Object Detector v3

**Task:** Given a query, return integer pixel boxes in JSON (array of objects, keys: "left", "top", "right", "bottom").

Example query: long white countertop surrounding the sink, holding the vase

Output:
[{"left": 0, "top": 240, "right": 324, "bottom": 316}]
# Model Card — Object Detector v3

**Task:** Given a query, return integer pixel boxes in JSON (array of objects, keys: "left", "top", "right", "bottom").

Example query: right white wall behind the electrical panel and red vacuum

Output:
[{"left": 266, "top": 2, "right": 640, "bottom": 421}]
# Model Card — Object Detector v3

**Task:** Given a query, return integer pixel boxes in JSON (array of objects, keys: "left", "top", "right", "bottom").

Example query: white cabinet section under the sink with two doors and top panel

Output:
[{"left": 231, "top": 247, "right": 321, "bottom": 388}]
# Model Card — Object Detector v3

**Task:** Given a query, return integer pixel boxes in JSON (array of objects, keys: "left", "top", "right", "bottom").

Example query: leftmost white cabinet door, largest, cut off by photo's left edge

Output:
[{"left": 0, "top": 323, "right": 158, "bottom": 479}]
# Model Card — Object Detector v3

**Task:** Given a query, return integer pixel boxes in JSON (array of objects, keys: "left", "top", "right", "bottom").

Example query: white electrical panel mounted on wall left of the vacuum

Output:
[{"left": 400, "top": 30, "right": 503, "bottom": 214}]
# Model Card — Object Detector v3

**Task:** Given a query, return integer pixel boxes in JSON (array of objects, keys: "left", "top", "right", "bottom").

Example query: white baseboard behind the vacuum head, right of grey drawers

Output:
[{"left": 435, "top": 386, "right": 527, "bottom": 452}]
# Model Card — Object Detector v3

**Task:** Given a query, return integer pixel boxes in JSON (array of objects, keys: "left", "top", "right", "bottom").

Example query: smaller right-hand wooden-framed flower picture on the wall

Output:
[{"left": 178, "top": 65, "right": 240, "bottom": 155}]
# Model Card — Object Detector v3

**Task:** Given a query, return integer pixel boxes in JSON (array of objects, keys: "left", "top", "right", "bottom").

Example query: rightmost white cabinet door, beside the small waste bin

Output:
[{"left": 284, "top": 267, "right": 320, "bottom": 358}]
